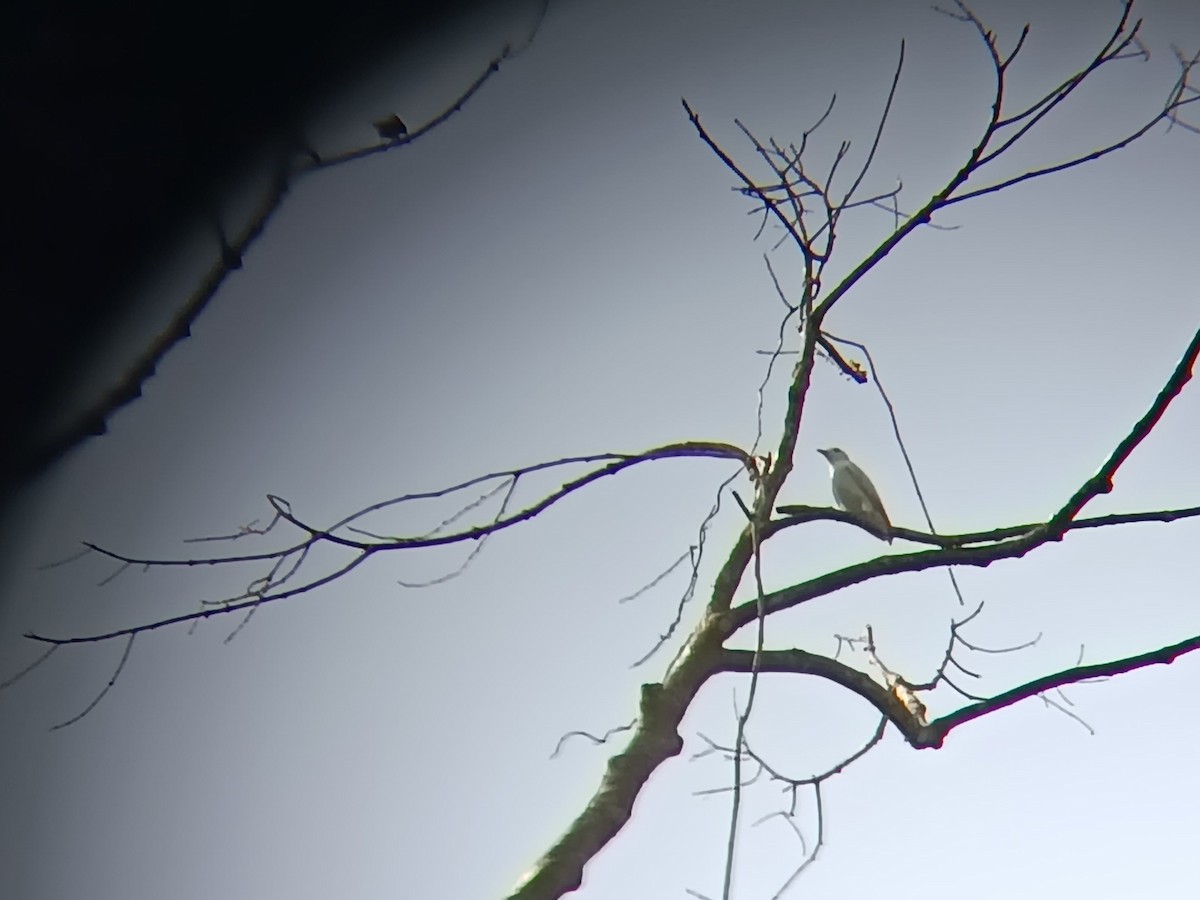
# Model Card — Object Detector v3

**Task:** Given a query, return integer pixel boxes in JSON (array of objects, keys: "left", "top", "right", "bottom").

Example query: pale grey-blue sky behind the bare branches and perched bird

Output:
[{"left": 0, "top": 0, "right": 1200, "bottom": 900}]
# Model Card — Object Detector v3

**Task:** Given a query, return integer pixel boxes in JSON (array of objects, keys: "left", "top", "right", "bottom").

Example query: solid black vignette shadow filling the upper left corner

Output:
[{"left": 0, "top": 0, "right": 535, "bottom": 511}]
